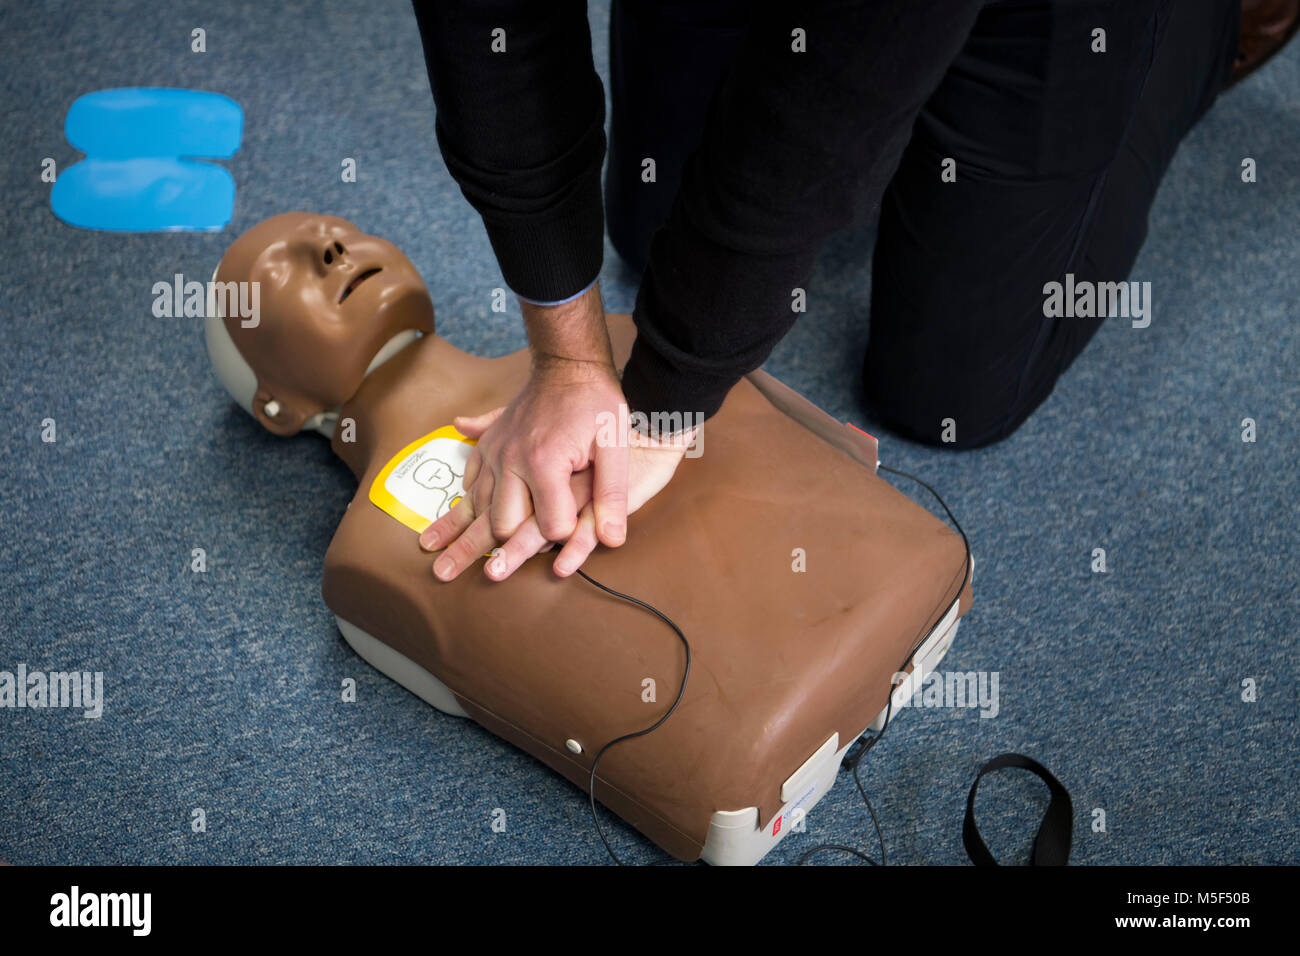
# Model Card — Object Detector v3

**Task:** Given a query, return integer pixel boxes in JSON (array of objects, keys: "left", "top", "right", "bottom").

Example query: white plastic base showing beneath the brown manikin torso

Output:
[{"left": 335, "top": 562, "right": 974, "bottom": 866}]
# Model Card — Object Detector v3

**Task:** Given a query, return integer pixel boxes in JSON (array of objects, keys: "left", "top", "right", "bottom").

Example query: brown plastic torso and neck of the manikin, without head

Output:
[{"left": 312, "top": 316, "right": 969, "bottom": 858}]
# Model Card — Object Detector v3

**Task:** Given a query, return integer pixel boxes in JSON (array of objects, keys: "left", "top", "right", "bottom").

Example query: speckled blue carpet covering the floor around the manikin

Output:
[{"left": 0, "top": 0, "right": 1300, "bottom": 864}]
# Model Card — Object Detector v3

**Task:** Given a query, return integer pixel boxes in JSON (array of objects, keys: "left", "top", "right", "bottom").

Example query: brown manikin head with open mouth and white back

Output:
[{"left": 205, "top": 212, "right": 433, "bottom": 434}]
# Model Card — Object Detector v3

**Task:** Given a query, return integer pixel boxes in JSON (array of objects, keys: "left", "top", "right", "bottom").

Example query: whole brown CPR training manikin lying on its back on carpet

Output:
[{"left": 205, "top": 212, "right": 971, "bottom": 864}]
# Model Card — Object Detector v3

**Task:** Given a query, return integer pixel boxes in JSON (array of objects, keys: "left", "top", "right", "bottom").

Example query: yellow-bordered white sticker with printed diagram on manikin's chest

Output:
[{"left": 371, "top": 425, "right": 476, "bottom": 533}]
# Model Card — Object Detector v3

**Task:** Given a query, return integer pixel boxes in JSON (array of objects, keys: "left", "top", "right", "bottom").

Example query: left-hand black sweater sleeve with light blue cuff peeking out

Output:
[{"left": 413, "top": 0, "right": 605, "bottom": 302}]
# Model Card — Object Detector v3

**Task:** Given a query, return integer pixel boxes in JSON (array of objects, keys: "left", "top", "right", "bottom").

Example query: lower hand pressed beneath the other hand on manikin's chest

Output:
[{"left": 420, "top": 429, "right": 693, "bottom": 581}]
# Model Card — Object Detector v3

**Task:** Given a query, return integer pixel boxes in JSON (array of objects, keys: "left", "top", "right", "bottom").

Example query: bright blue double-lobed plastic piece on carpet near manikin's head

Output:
[{"left": 49, "top": 87, "right": 243, "bottom": 233}]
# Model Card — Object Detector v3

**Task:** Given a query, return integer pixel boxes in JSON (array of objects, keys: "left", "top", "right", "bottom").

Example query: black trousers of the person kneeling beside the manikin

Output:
[{"left": 606, "top": 0, "right": 1240, "bottom": 447}]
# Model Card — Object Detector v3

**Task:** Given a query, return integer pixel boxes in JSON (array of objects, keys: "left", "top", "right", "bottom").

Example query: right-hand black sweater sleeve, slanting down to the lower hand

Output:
[{"left": 623, "top": 0, "right": 983, "bottom": 418}]
